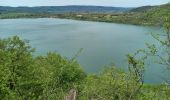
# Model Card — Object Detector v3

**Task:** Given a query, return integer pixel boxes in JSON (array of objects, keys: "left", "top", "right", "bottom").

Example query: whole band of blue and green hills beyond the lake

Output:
[{"left": 0, "top": 4, "right": 170, "bottom": 26}]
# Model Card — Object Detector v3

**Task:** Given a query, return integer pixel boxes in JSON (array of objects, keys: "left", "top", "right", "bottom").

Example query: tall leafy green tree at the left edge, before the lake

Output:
[{"left": 0, "top": 36, "right": 34, "bottom": 97}]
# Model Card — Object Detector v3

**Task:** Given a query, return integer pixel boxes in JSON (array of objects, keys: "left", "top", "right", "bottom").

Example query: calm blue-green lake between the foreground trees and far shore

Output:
[{"left": 0, "top": 18, "right": 167, "bottom": 83}]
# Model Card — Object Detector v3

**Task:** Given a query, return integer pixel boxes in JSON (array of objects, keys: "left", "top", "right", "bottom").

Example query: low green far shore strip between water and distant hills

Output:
[{"left": 0, "top": 13, "right": 158, "bottom": 26}]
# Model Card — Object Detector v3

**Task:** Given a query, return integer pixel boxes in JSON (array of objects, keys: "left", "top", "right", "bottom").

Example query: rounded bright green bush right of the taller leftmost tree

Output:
[{"left": 34, "top": 52, "right": 86, "bottom": 99}]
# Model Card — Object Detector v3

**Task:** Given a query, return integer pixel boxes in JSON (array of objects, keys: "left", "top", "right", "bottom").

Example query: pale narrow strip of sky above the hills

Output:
[{"left": 0, "top": 0, "right": 170, "bottom": 7}]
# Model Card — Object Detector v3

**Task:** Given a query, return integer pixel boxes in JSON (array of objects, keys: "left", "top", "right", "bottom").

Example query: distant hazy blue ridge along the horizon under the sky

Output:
[{"left": 0, "top": 5, "right": 131, "bottom": 13}]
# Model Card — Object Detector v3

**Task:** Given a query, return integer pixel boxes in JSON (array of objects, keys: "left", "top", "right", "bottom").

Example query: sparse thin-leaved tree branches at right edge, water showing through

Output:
[{"left": 141, "top": 17, "right": 170, "bottom": 84}]
